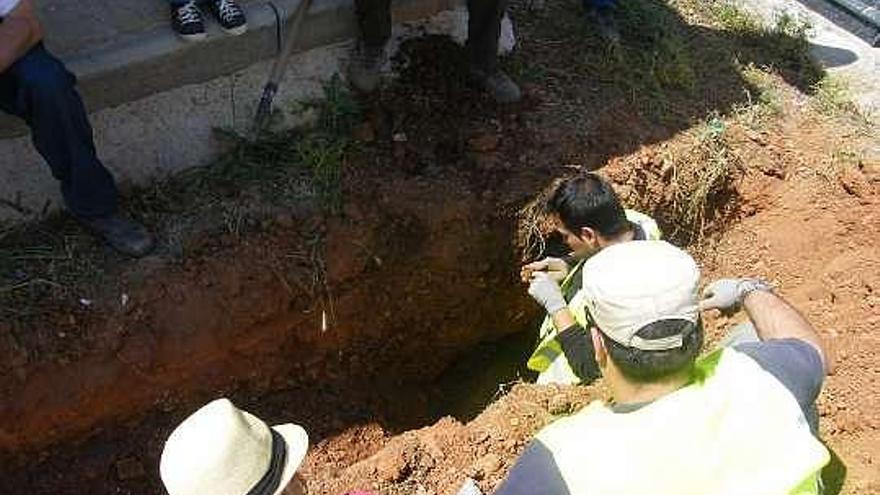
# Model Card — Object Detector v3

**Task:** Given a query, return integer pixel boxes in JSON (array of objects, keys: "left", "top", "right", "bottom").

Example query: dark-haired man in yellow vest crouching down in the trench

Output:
[{"left": 521, "top": 173, "right": 660, "bottom": 384}]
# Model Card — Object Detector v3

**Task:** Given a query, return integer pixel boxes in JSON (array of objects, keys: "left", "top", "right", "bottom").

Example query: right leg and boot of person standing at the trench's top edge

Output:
[{"left": 467, "top": 0, "right": 522, "bottom": 103}]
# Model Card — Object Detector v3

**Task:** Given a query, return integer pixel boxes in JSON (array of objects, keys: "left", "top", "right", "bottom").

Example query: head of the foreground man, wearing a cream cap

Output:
[{"left": 583, "top": 241, "right": 703, "bottom": 398}]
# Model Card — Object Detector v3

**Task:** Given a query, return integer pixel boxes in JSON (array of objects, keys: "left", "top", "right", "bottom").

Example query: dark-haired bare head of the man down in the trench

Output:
[{"left": 547, "top": 173, "right": 633, "bottom": 258}]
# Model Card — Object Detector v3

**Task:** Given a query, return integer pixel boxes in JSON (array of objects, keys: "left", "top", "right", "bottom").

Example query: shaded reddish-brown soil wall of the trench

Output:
[{"left": 0, "top": 166, "right": 536, "bottom": 457}]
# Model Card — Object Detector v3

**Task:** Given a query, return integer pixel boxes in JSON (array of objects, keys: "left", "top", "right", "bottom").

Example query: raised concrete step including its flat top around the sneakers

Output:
[{"left": 0, "top": 0, "right": 455, "bottom": 138}]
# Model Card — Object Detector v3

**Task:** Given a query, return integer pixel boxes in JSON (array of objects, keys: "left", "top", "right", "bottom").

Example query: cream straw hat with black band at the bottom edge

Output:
[{"left": 159, "top": 399, "right": 309, "bottom": 495}]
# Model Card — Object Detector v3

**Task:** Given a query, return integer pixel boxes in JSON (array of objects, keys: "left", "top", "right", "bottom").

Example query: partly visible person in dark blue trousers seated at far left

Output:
[{"left": 0, "top": 0, "right": 154, "bottom": 256}]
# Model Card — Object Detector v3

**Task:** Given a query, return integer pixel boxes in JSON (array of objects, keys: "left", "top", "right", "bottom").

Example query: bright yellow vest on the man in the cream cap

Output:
[{"left": 536, "top": 348, "right": 830, "bottom": 495}]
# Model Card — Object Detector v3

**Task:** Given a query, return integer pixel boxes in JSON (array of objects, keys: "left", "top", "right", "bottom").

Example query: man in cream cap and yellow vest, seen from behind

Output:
[{"left": 495, "top": 241, "right": 829, "bottom": 495}]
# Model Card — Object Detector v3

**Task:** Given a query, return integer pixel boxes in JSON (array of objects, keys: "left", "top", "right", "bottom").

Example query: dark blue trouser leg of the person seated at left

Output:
[{"left": 0, "top": 44, "right": 118, "bottom": 218}]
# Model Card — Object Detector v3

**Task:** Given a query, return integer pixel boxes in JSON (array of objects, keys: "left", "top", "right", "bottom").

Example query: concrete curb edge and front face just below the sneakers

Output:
[{"left": 0, "top": 0, "right": 458, "bottom": 139}]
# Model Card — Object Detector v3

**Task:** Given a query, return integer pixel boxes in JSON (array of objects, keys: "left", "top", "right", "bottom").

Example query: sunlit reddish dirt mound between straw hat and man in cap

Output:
[{"left": 303, "top": 384, "right": 602, "bottom": 495}]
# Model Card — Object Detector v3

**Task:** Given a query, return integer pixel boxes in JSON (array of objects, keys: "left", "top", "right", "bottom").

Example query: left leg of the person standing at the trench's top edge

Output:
[{"left": 348, "top": 0, "right": 391, "bottom": 93}]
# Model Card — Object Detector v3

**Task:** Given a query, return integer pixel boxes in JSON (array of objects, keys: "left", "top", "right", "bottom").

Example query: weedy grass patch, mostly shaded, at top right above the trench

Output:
[{"left": 505, "top": 0, "right": 822, "bottom": 126}]
